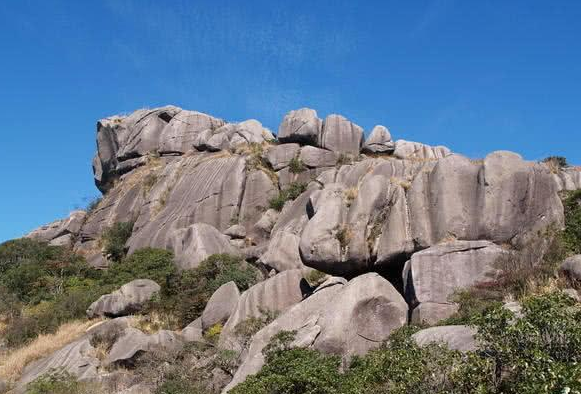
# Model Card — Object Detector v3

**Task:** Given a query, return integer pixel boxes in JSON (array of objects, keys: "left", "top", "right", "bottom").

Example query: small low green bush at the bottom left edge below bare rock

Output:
[{"left": 26, "top": 371, "right": 105, "bottom": 394}]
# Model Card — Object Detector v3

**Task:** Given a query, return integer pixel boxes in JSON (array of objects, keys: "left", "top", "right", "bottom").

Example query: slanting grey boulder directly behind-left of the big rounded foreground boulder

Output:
[{"left": 220, "top": 269, "right": 310, "bottom": 349}]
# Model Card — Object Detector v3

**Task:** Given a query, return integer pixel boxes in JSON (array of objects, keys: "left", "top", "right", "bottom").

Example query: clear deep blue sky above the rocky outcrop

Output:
[{"left": 0, "top": 0, "right": 581, "bottom": 241}]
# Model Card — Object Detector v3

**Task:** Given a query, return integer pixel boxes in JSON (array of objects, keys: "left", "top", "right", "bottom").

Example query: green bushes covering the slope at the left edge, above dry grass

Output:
[{"left": 0, "top": 239, "right": 176, "bottom": 348}]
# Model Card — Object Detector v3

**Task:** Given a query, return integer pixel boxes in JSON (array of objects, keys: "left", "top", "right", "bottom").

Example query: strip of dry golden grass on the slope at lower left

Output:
[{"left": 0, "top": 320, "right": 101, "bottom": 381}]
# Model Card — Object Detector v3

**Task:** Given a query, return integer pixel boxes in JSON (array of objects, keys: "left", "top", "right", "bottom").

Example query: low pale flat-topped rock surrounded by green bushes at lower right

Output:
[{"left": 412, "top": 326, "right": 478, "bottom": 352}]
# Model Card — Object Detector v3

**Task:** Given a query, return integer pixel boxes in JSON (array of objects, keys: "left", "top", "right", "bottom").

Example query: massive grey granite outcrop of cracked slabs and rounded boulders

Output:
[{"left": 20, "top": 106, "right": 581, "bottom": 394}]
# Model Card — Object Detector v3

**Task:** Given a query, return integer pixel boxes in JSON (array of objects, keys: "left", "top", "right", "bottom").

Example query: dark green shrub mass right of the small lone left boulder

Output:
[{"left": 146, "top": 254, "right": 259, "bottom": 328}]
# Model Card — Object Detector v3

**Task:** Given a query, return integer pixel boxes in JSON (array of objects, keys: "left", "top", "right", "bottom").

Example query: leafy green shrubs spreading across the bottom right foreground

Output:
[{"left": 231, "top": 293, "right": 581, "bottom": 394}]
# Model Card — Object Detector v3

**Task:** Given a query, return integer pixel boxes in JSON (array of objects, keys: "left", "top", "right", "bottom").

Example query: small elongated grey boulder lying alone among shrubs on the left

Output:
[{"left": 87, "top": 279, "right": 160, "bottom": 318}]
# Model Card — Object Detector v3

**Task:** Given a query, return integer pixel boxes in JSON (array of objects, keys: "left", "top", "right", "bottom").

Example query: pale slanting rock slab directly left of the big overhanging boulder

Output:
[{"left": 260, "top": 189, "right": 315, "bottom": 272}]
